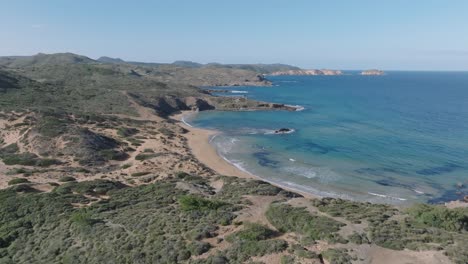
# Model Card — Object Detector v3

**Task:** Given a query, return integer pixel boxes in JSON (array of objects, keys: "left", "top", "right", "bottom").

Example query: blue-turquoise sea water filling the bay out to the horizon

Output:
[{"left": 186, "top": 72, "right": 468, "bottom": 204}]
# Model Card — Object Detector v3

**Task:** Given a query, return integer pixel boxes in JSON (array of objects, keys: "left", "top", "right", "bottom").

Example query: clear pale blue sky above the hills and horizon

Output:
[{"left": 0, "top": 0, "right": 468, "bottom": 70}]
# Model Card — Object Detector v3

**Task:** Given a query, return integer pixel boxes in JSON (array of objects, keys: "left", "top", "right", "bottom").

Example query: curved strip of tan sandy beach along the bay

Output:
[{"left": 170, "top": 111, "right": 322, "bottom": 199}]
